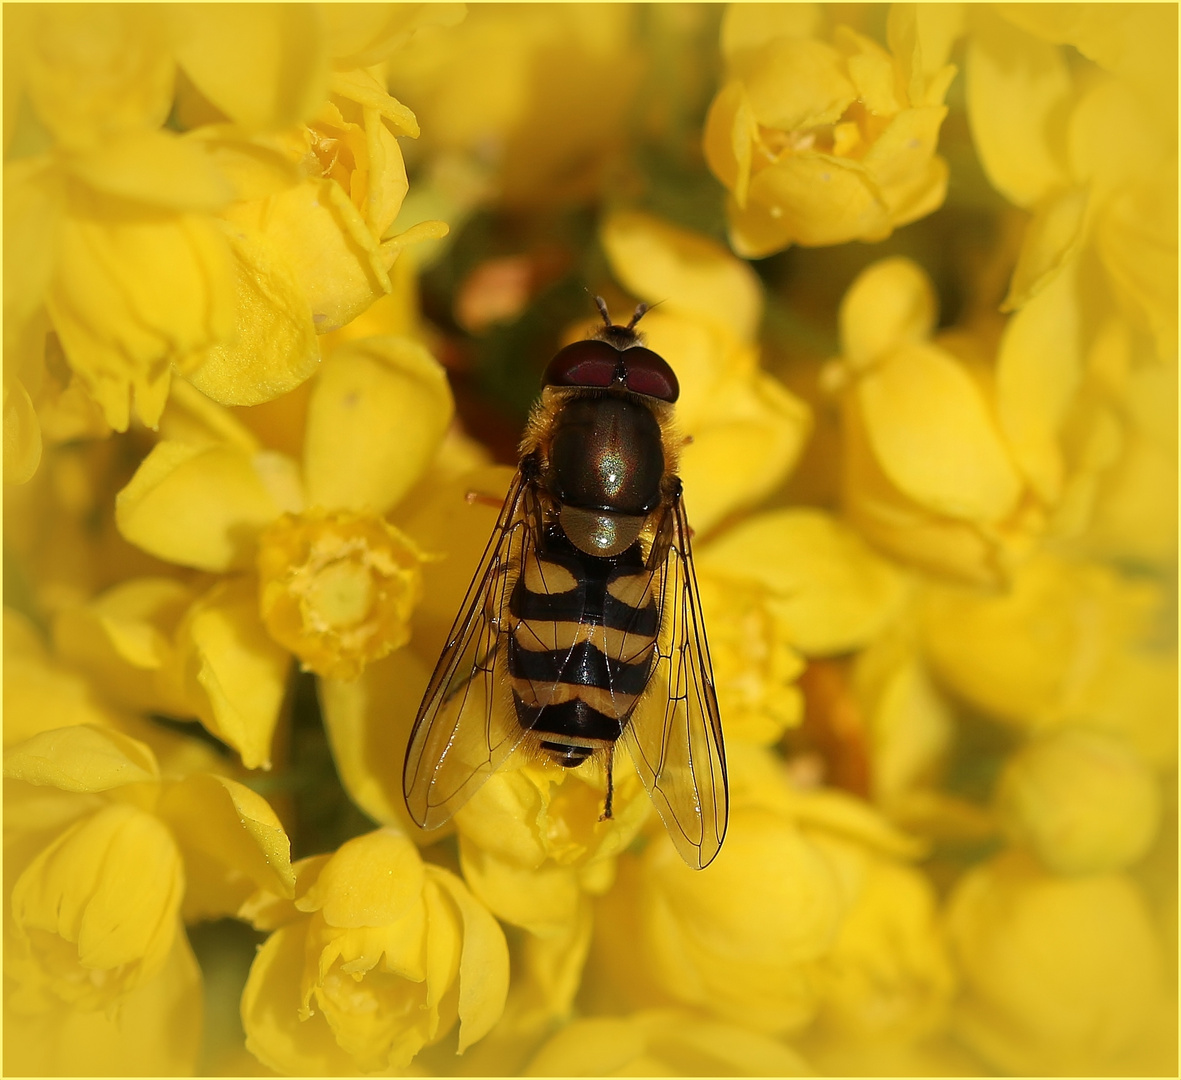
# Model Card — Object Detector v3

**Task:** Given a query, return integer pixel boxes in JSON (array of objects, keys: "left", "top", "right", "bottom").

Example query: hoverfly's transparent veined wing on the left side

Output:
[{"left": 402, "top": 471, "right": 536, "bottom": 828}]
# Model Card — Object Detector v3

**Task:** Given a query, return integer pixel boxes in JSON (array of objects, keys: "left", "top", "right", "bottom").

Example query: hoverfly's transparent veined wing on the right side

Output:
[{"left": 624, "top": 495, "right": 729, "bottom": 868}]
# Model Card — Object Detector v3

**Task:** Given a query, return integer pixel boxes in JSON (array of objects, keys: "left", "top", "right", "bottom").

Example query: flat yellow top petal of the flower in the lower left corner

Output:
[{"left": 4, "top": 727, "right": 159, "bottom": 792}]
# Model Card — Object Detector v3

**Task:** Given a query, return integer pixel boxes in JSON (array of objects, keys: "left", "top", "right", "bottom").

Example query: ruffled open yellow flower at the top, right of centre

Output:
[{"left": 704, "top": 5, "right": 958, "bottom": 258}]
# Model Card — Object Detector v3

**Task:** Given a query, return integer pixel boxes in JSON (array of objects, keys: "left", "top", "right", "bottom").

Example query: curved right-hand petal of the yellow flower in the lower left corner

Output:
[{"left": 156, "top": 774, "right": 295, "bottom": 922}]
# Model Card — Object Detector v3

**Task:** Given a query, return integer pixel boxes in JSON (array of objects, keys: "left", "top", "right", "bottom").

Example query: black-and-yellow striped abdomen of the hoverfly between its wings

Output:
[{"left": 508, "top": 538, "right": 659, "bottom": 766}]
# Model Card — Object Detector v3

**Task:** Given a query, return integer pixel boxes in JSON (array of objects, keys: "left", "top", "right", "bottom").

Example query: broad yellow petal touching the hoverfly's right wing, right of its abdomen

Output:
[{"left": 697, "top": 510, "right": 903, "bottom": 656}]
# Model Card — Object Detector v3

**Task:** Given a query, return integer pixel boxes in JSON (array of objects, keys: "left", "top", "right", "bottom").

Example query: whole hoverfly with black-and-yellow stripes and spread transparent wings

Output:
[{"left": 403, "top": 297, "right": 729, "bottom": 867}]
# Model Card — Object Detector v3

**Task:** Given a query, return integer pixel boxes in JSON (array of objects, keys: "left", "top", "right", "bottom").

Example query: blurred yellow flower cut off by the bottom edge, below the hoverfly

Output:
[{"left": 522, "top": 1009, "right": 813, "bottom": 1076}]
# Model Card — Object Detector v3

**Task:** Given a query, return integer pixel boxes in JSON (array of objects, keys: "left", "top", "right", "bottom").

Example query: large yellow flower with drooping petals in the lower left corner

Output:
[{"left": 5, "top": 726, "right": 294, "bottom": 1068}]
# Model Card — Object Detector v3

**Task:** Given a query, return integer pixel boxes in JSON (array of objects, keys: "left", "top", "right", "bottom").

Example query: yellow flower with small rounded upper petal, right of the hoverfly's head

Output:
[{"left": 828, "top": 258, "right": 1039, "bottom": 583}]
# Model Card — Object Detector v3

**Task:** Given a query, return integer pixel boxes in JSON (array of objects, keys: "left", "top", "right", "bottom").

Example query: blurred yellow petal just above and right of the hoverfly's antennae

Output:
[{"left": 600, "top": 210, "right": 763, "bottom": 341}]
